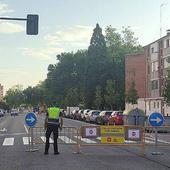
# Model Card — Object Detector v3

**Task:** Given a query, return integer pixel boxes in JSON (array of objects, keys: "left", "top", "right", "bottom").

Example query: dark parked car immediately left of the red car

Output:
[{"left": 96, "top": 110, "right": 113, "bottom": 125}]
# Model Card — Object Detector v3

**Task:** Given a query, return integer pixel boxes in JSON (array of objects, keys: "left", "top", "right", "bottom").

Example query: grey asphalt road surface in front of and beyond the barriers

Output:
[{"left": 0, "top": 114, "right": 170, "bottom": 170}]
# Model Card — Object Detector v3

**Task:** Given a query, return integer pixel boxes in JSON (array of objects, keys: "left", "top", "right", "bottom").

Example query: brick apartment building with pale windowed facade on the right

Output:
[{"left": 125, "top": 30, "right": 170, "bottom": 116}]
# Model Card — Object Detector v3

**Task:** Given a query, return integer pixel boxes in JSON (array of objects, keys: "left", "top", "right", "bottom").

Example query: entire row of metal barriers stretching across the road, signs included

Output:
[{"left": 28, "top": 125, "right": 170, "bottom": 155}]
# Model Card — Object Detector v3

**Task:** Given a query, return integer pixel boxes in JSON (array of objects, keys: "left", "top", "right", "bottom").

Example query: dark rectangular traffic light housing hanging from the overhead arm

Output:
[{"left": 27, "top": 14, "right": 38, "bottom": 35}]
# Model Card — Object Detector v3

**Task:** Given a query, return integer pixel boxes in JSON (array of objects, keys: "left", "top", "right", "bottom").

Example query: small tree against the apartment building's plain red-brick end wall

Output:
[{"left": 126, "top": 81, "right": 138, "bottom": 104}]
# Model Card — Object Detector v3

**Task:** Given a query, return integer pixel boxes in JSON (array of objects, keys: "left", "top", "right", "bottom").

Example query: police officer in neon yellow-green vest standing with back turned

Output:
[{"left": 44, "top": 107, "right": 63, "bottom": 155}]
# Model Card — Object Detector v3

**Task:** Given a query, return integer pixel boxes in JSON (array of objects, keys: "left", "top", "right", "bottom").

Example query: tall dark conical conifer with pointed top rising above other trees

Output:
[{"left": 85, "top": 24, "right": 111, "bottom": 108}]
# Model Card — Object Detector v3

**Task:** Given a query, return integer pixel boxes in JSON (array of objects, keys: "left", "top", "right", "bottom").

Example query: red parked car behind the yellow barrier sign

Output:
[{"left": 109, "top": 111, "right": 123, "bottom": 125}]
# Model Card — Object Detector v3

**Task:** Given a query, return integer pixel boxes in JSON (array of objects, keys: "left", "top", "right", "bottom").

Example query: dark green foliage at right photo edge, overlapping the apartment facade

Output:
[{"left": 163, "top": 70, "right": 170, "bottom": 105}]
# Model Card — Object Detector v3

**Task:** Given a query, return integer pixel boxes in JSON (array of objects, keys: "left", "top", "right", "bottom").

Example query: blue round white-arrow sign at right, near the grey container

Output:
[{"left": 148, "top": 112, "right": 164, "bottom": 127}]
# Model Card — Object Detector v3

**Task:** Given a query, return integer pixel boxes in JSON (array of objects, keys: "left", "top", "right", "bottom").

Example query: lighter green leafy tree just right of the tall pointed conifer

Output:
[{"left": 105, "top": 26, "right": 143, "bottom": 109}]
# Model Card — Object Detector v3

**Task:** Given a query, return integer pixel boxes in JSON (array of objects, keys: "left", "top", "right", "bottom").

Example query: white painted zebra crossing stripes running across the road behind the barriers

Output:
[{"left": 0, "top": 136, "right": 170, "bottom": 147}]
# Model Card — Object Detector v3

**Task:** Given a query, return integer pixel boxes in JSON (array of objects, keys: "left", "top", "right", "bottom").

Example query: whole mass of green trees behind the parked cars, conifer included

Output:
[{"left": 5, "top": 24, "right": 142, "bottom": 110}]
